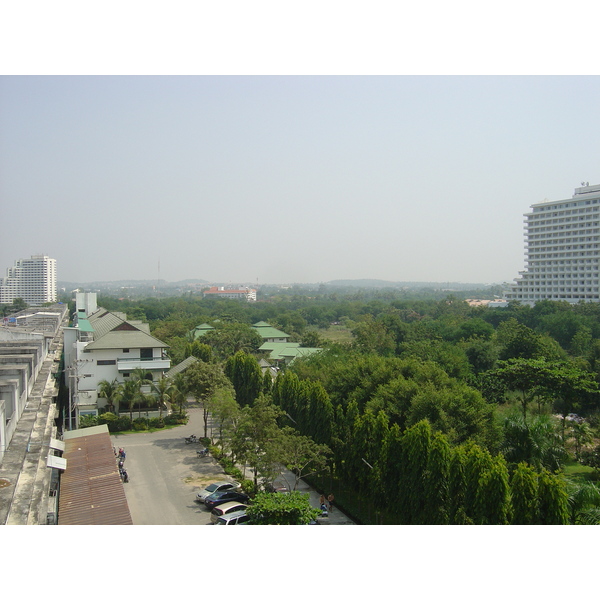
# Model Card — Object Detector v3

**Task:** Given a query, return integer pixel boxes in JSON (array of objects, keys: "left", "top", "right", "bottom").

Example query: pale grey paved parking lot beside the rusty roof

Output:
[{"left": 111, "top": 404, "right": 228, "bottom": 525}]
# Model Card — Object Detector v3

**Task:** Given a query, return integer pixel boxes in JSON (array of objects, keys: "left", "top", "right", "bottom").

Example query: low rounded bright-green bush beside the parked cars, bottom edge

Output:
[{"left": 246, "top": 492, "right": 321, "bottom": 525}]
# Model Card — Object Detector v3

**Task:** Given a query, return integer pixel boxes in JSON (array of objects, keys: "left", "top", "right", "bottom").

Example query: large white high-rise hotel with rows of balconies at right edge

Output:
[{"left": 507, "top": 184, "right": 600, "bottom": 304}]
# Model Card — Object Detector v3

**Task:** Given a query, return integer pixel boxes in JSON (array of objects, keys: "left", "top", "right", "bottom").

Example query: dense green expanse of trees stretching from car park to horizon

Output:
[{"left": 90, "top": 292, "right": 600, "bottom": 524}]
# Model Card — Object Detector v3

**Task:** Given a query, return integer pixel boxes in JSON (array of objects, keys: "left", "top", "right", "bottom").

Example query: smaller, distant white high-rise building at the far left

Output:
[{"left": 0, "top": 254, "right": 56, "bottom": 306}]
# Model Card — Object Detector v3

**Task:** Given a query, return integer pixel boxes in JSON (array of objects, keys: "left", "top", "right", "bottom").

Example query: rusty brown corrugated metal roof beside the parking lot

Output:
[{"left": 58, "top": 427, "right": 133, "bottom": 525}]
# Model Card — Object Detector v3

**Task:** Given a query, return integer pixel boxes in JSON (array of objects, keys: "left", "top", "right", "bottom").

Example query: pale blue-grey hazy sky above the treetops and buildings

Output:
[{"left": 0, "top": 76, "right": 600, "bottom": 284}]
